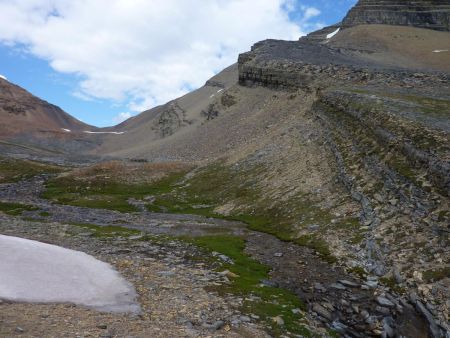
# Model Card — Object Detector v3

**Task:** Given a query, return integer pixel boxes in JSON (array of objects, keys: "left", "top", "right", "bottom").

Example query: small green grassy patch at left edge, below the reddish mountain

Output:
[{"left": 0, "top": 157, "right": 65, "bottom": 183}]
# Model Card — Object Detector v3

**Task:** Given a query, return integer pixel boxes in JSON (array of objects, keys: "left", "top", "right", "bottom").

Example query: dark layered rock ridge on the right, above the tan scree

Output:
[{"left": 239, "top": 1, "right": 450, "bottom": 338}]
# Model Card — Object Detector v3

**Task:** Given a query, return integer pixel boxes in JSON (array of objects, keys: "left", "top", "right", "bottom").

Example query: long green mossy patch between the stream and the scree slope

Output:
[{"left": 43, "top": 164, "right": 335, "bottom": 263}]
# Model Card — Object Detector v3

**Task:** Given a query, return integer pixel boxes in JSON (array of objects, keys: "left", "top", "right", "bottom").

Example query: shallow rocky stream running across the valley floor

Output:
[{"left": 0, "top": 175, "right": 429, "bottom": 338}]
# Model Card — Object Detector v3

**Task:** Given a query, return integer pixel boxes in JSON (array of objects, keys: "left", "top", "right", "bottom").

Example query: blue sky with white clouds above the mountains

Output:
[{"left": 0, "top": 0, "right": 356, "bottom": 127}]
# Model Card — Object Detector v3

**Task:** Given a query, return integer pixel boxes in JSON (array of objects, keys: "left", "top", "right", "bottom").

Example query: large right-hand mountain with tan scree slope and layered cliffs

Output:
[{"left": 0, "top": 1, "right": 450, "bottom": 338}]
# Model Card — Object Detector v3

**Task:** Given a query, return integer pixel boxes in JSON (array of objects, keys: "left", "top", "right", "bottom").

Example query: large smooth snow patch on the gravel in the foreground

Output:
[{"left": 0, "top": 235, "right": 139, "bottom": 312}]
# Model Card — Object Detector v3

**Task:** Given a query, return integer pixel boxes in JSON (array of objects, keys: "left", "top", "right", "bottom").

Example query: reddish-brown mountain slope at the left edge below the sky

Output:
[{"left": 0, "top": 79, "right": 103, "bottom": 160}]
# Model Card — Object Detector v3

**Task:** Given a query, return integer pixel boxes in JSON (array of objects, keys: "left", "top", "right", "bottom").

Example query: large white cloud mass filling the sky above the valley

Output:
[{"left": 0, "top": 0, "right": 319, "bottom": 111}]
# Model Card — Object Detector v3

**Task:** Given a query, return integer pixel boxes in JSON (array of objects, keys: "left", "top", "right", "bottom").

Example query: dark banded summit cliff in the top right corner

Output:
[{"left": 342, "top": 0, "right": 450, "bottom": 31}]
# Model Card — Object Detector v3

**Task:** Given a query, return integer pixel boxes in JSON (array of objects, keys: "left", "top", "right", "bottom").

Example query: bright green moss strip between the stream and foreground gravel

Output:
[{"left": 185, "top": 236, "right": 311, "bottom": 337}]
